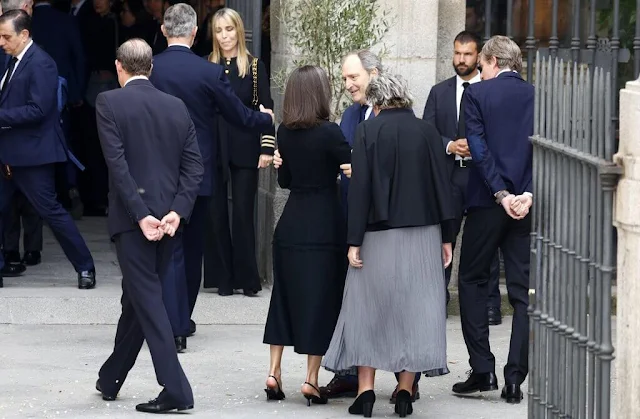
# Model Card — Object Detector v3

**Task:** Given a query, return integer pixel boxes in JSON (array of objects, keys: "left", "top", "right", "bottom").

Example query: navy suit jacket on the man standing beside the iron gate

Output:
[{"left": 462, "top": 71, "right": 534, "bottom": 208}]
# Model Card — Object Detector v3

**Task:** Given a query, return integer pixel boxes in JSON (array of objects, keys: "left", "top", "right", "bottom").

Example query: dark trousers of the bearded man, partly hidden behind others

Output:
[{"left": 444, "top": 165, "right": 501, "bottom": 308}]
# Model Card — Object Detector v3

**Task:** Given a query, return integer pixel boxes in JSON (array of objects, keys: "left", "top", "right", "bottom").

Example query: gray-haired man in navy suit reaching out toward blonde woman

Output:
[{"left": 150, "top": 3, "right": 273, "bottom": 350}]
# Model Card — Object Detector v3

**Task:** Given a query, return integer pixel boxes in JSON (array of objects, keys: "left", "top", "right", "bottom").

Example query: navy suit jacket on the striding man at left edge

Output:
[{"left": 0, "top": 43, "right": 67, "bottom": 166}]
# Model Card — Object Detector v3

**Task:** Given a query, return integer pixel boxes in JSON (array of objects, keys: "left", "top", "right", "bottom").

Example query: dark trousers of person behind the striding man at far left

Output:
[{"left": 3, "top": 191, "right": 43, "bottom": 252}]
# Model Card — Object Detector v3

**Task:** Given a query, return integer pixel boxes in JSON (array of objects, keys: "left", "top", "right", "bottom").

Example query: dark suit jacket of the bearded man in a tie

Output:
[{"left": 422, "top": 76, "right": 462, "bottom": 175}]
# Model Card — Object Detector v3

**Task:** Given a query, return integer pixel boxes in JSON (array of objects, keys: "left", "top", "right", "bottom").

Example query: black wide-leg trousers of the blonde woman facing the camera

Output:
[{"left": 204, "top": 166, "right": 262, "bottom": 293}]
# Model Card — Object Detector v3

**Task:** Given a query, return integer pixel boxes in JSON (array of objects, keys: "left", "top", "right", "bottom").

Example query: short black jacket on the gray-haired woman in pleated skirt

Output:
[{"left": 347, "top": 109, "right": 456, "bottom": 246}]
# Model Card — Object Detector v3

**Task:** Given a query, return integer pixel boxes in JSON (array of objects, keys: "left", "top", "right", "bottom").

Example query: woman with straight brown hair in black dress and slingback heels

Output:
[{"left": 264, "top": 66, "right": 351, "bottom": 404}]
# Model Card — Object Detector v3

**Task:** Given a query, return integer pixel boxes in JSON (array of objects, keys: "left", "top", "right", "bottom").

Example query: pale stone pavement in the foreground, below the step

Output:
[{"left": 0, "top": 324, "right": 526, "bottom": 419}]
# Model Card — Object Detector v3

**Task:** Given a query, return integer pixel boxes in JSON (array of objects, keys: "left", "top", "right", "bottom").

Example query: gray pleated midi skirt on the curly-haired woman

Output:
[{"left": 322, "top": 225, "right": 449, "bottom": 376}]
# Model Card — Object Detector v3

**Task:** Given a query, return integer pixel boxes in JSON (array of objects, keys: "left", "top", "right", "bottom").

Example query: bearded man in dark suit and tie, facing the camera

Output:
[{"left": 422, "top": 31, "right": 502, "bottom": 325}]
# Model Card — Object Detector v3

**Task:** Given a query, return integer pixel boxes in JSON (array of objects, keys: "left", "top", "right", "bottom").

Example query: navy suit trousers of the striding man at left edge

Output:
[{"left": 0, "top": 164, "right": 95, "bottom": 272}]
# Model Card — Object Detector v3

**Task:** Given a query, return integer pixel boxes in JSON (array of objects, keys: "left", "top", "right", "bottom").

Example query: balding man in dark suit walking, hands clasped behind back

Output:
[{"left": 96, "top": 39, "right": 204, "bottom": 413}]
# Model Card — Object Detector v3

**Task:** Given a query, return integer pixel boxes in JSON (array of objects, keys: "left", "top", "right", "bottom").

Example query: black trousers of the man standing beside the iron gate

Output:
[{"left": 458, "top": 206, "right": 531, "bottom": 384}]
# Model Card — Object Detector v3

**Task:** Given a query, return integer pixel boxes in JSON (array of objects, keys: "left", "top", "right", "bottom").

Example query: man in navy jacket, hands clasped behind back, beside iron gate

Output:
[{"left": 453, "top": 36, "right": 534, "bottom": 403}]
